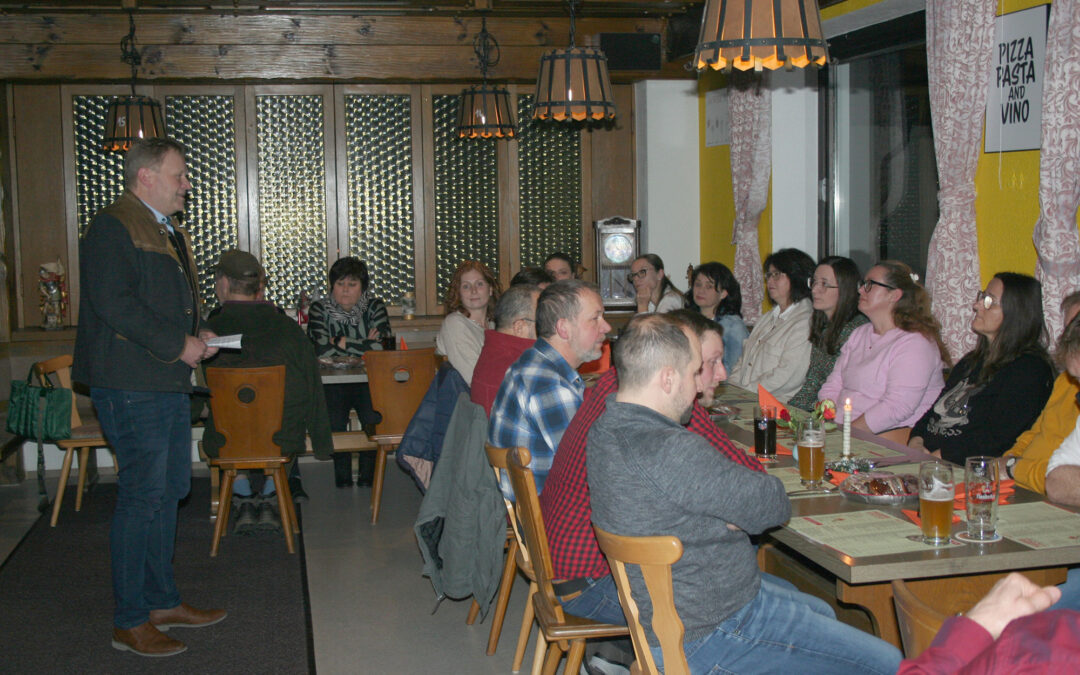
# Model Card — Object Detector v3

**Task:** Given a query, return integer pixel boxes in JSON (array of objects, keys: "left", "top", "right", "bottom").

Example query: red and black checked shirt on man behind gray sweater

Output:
[{"left": 540, "top": 368, "right": 765, "bottom": 579}]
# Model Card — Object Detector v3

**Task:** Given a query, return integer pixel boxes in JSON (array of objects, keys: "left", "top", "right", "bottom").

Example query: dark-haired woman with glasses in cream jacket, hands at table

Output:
[{"left": 728, "top": 248, "right": 814, "bottom": 402}]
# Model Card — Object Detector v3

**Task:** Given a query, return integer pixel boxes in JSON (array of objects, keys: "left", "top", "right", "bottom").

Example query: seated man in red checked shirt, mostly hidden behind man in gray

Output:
[{"left": 540, "top": 310, "right": 764, "bottom": 624}]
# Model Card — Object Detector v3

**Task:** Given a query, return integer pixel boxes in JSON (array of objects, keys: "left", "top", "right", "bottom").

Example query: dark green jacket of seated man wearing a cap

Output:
[{"left": 203, "top": 302, "right": 334, "bottom": 459}]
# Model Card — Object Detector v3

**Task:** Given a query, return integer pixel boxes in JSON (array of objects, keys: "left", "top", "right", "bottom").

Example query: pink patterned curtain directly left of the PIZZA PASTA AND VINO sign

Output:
[{"left": 927, "top": 0, "right": 998, "bottom": 360}]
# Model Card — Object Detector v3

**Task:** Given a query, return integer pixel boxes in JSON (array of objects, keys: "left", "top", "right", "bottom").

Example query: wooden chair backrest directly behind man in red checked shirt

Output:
[{"left": 507, "top": 447, "right": 566, "bottom": 625}]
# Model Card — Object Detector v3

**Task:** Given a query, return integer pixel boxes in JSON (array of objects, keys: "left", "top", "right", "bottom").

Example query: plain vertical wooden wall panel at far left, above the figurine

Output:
[{"left": 13, "top": 84, "right": 72, "bottom": 327}]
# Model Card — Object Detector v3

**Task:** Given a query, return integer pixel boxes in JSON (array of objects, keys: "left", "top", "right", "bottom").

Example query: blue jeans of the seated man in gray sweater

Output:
[{"left": 652, "top": 578, "right": 903, "bottom": 675}]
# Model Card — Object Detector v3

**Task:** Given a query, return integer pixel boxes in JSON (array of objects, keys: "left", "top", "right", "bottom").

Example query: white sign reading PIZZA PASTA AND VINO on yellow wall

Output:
[{"left": 985, "top": 4, "right": 1050, "bottom": 152}]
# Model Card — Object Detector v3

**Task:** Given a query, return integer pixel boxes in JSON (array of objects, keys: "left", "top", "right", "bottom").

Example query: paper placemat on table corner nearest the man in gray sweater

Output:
[{"left": 787, "top": 510, "right": 960, "bottom": 557}]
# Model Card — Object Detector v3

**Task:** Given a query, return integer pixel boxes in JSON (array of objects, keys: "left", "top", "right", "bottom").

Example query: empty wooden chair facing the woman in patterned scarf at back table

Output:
[{"left": 364, "top": 347, "right": 435, "bottom": 525}]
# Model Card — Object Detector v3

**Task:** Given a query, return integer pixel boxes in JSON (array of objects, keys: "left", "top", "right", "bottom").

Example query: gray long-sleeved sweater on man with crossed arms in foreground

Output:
[{"left": 585, "top": 394, "right": 792, "bottom": 646}]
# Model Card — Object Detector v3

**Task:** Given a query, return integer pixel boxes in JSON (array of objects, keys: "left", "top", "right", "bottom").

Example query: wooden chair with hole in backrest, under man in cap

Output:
[{"left": 206, "top": 365, "right": 297, "bottom": 556}]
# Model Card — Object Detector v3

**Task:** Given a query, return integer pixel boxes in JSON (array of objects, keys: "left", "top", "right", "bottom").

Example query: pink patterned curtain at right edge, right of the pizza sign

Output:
[{"left": 1032, "top": 0, "right": 1080, "bottom": 340}]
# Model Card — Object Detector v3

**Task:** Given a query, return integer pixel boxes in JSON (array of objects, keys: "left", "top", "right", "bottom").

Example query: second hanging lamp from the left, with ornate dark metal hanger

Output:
[{"left": 458, "top": 16, "right": 515, "bottom": 138}]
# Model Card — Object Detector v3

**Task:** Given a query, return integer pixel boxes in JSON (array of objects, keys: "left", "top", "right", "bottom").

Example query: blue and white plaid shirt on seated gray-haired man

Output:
[{"left": 487, "top": 338, "right": 585, "bottom": 499}]
